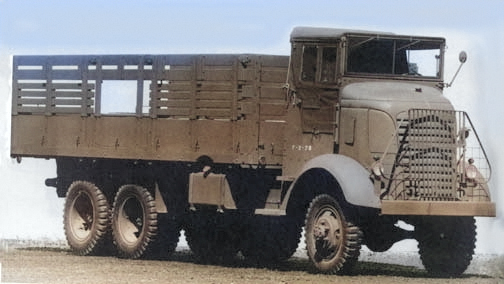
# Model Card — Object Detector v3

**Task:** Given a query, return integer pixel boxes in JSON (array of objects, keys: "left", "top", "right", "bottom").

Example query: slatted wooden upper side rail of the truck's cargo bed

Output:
[{"left": 12, "top": 54, "right": 288, "bottom": 120}]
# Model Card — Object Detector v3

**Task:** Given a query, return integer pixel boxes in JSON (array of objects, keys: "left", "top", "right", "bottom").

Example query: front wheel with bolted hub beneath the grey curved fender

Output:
[{"left": 305, "top": 194, "right": 362, "bottom": 274}]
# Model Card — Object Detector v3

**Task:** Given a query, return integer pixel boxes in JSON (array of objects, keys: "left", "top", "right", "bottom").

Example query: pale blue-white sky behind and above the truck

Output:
[{"left": 0, "top": 0, "right": 504, "bottom": 253}]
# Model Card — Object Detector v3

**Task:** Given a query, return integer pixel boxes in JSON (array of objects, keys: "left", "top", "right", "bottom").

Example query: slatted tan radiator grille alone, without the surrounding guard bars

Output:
[{"left": 400, "top": 109, "right": 457, "bottom": 200}]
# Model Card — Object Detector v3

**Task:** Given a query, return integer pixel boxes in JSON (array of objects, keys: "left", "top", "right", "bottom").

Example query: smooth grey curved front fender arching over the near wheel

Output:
[{"left": 289, "top": 154, "right": 381, "bottom": 208}]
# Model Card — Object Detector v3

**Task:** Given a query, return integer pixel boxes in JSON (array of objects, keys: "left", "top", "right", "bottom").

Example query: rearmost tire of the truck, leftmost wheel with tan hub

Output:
[{"left": 63, "top": 181, "right": 110, "bottom": 255}]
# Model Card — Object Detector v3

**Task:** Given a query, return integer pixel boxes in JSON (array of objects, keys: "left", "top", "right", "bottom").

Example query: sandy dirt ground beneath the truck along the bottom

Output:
[{"left": 0, "top": 242, "right": 504, "bottom": 284}]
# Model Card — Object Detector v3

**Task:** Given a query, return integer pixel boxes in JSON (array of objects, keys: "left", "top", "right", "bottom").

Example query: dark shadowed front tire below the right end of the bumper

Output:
[{"left": 415, "top": 217, "right": 476, "bottom": 277}]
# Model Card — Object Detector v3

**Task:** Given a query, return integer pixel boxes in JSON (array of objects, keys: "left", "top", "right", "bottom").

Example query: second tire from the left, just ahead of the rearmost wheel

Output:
[{"left": 112, "top": 185, "right": 157, "bottom": 258}]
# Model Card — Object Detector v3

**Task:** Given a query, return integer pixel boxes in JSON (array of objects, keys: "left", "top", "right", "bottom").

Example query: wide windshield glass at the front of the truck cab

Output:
[{"left": 346, "top": 35, "right": 443, "bottom": 78}]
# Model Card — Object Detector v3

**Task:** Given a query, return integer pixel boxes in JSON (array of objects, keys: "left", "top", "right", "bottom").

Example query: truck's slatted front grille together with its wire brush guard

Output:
[{"left": 382, "top": 109, "right": 491, "bottom": 201}]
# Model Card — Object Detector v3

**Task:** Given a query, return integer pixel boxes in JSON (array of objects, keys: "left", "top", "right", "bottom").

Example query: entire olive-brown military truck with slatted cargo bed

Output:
[{"left": 11, "top": 27, "right": 496, "bottom": 277}]
